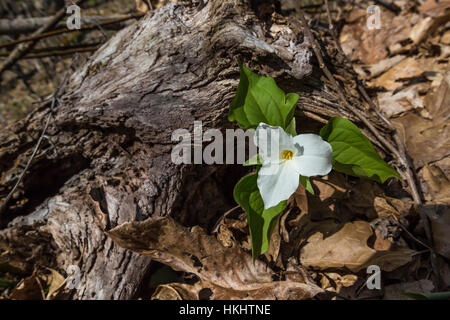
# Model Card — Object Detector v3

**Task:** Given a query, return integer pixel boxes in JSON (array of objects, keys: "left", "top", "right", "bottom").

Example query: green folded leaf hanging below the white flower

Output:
[{"left": 234, "top": 174, "right": 287, "bottom": 260}]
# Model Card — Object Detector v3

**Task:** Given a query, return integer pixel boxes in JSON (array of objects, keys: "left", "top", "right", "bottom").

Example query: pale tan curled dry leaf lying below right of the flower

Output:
[{"left": 300, "top": 221, "right": 415, "bottom": 272}]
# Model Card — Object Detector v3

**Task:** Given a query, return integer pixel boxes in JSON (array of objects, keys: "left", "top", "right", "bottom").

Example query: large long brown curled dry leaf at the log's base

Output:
[{"left": 107, "top": 217, "right": 322, "bottom": 299}]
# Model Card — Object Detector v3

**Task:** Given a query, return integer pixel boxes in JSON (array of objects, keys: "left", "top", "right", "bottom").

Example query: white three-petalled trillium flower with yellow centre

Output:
[{"left": 254, "top": 123, "right": 332, "bottom": 209}]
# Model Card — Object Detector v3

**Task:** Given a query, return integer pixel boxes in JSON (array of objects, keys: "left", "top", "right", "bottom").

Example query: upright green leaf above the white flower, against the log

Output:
[{"left": 228, "top": 64, "right": 299, "bottom": 131}]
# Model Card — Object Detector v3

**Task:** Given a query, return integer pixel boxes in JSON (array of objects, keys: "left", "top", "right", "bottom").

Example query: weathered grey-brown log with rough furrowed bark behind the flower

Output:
[{"left": 0, "top": 0, "right": 394, "bottom": 299}]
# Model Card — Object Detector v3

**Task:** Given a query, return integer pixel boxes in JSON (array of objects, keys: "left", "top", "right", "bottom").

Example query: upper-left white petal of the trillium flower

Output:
[{"left": 254, "top": 123, "right": 297, "bottom": 163}]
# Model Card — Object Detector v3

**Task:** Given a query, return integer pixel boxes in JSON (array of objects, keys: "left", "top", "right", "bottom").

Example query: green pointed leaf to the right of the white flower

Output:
[{"left": 320, "top": 118, "right": 401, "bottom": 183}]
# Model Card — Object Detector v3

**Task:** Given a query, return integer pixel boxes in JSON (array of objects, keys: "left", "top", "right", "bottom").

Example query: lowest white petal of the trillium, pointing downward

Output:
[{"left": 258, "top": 161, "right": 300, "bottom": 209}]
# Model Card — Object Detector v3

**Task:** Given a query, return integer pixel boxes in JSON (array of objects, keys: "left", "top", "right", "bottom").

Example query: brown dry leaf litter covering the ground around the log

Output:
[{"left": 0, "top": 0, "right": 450, "bottom": 300}]
